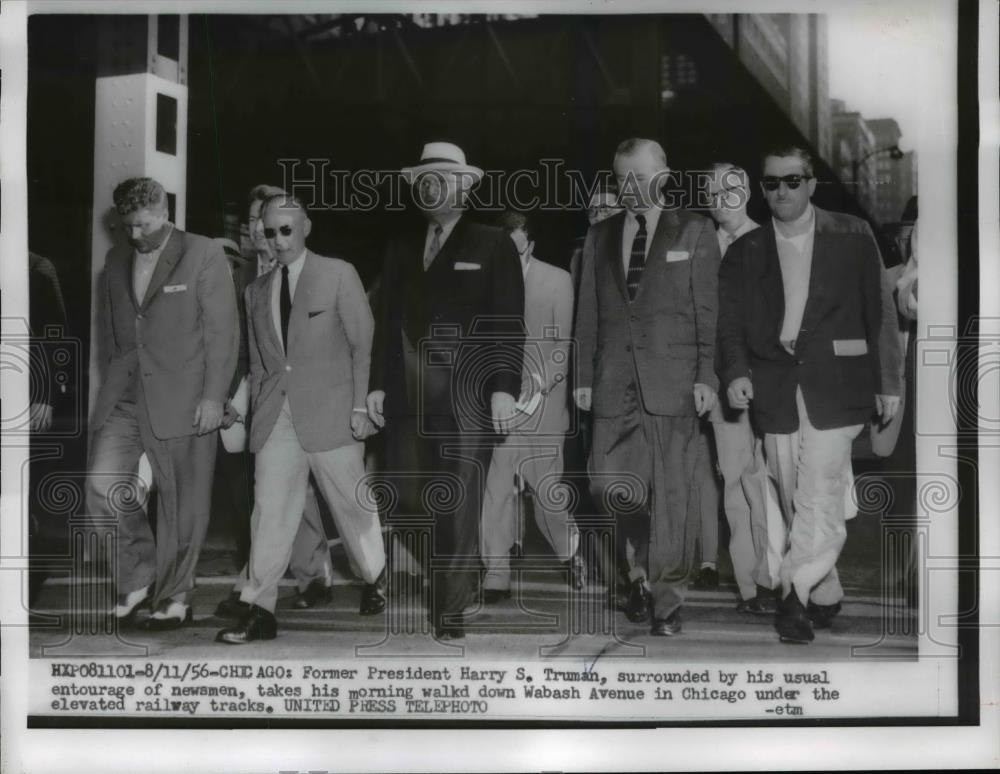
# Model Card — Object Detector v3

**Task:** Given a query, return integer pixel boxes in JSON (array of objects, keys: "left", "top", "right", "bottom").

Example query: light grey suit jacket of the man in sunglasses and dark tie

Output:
[{"left": 246, "top": 250, "right": 373, "bottom": 453}]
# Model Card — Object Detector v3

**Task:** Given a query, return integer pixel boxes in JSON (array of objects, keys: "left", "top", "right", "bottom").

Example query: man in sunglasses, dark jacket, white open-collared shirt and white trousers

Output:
[{"left": 718, "top": 146, "right": 900, "bottom": 643}]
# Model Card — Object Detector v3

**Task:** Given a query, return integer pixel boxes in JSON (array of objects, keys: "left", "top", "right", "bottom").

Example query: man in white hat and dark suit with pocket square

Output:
[{"left": 367, "top": 142, "right": 524, "bottom": 639}]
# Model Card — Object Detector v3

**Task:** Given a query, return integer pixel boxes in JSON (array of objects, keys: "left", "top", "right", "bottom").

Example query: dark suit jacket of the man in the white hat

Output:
[{"left": 372, "top": 215, "right": 524, "bottom": 429}]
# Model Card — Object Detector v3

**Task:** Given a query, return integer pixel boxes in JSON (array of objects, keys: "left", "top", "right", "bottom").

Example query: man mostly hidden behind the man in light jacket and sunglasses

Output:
[{"left": 215, "top": 183, "right": 342, "bottom": 619}]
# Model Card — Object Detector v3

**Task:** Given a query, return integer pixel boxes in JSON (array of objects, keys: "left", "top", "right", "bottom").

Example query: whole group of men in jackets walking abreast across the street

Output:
[{"left": 88, "top": 139, "right": 899, "bottom": 644}]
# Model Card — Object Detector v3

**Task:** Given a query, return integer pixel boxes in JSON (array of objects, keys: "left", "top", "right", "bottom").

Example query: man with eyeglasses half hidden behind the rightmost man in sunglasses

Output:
[{"left": 702, "top": 162, "right": 784, "bottom": 615}]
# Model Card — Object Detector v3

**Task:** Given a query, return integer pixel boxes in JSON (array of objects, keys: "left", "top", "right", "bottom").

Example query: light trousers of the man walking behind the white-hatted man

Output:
[{"left": 480, "top": 435, "right": 580, "bottom": 589}]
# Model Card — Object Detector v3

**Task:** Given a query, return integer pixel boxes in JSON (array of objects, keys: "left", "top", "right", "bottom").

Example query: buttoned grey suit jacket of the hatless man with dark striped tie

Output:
[{"left": 576, "top": 210, "right": 720, "bottom": 417}]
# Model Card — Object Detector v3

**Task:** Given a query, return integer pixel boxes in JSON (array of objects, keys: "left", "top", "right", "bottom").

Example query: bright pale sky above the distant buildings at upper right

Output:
[{"left": 827, "top": 3, "right": 943, "bottom": 150}]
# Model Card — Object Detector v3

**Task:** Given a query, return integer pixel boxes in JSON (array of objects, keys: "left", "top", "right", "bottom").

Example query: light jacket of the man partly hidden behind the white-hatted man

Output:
[{"left": 521, "top": 258, "right": 573, "bottom": 435}]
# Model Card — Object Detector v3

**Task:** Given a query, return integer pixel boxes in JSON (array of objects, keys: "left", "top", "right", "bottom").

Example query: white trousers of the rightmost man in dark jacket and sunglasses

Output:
[{"left": 764, "top": 390, "right": 864, "bottom": 605}]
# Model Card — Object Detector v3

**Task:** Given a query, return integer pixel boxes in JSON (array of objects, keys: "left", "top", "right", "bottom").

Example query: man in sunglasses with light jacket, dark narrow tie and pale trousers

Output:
[{"left": 216, "top": 194, "right": 385, "bottom": 645}]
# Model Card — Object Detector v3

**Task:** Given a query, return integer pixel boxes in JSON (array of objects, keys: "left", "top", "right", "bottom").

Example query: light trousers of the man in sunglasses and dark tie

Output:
[{"left": 240, "top": 400, "right": 385, "bottom": 612}]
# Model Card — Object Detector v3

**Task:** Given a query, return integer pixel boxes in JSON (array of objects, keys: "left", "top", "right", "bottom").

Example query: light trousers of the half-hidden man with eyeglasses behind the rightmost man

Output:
[{"left": 712, "top": 410, "right": 785, "bottom": 599}]
